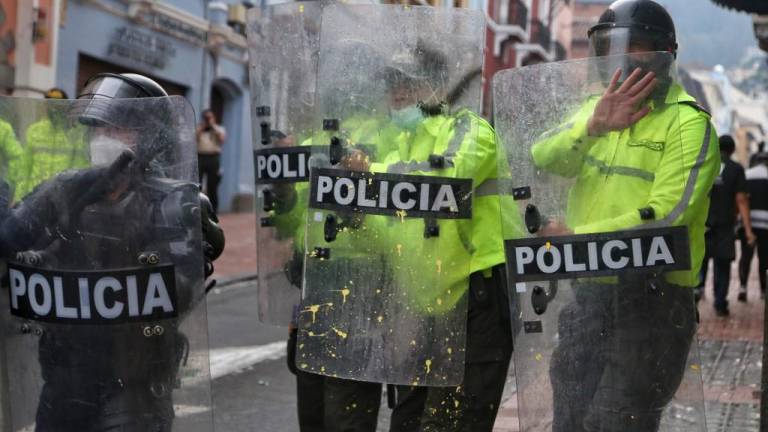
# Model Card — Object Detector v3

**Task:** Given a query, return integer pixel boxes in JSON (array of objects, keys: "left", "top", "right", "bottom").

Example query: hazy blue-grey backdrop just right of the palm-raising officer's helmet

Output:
[{"left": 660, "top": 0, "right": 757, "bottom": 67}]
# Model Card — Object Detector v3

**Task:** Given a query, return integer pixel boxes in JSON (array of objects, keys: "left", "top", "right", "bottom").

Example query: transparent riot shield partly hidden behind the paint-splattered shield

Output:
[{"left": 248, "top": 2, "right": 322, "bottom": 325}]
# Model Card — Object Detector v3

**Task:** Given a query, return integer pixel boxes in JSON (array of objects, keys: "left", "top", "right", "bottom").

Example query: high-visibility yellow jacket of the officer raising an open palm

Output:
[{"left": 532, "top": 84, "right": 720, "bottom": 286}]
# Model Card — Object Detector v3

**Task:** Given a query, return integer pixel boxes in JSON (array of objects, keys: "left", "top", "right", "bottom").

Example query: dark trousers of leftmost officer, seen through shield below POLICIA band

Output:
[{"left": 35, "top": 326, "right": 187, "bottom": 432}]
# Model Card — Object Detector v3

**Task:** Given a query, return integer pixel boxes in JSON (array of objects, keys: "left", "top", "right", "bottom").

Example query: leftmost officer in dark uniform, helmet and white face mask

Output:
[{"left": 0, "top": 73, "right": 224, "bottom": 432}]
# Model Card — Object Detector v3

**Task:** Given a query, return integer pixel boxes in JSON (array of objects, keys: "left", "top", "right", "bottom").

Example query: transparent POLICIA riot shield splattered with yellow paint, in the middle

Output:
[{"left": 296, "top": 4, "right": 483, "bottom": 386}]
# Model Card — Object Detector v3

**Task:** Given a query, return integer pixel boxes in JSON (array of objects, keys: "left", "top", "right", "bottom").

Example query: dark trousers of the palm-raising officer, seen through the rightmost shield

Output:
[{"left": 550, "top": 280, "right": 696, "bottom": 432}]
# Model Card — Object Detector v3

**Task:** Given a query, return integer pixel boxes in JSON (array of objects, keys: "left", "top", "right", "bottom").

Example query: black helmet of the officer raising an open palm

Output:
[{"left": 587, "top": 0, "right": 677, "bottom": 57}]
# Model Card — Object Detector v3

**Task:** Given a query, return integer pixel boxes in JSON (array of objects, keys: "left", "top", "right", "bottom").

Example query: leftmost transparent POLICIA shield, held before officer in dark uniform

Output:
[{"left": 0, "top": 97, "right": 213, "bottom": 432}]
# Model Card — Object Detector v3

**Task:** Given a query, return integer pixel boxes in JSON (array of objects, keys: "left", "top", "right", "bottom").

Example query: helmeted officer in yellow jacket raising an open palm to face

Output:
[{"left": 510, "top": 0, "right": 718, "bottom": 432}]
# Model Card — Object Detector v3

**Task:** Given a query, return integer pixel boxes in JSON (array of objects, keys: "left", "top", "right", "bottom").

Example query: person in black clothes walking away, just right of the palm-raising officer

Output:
[{"left": 696, "top": 135, "right": 755, "bottom": 317}]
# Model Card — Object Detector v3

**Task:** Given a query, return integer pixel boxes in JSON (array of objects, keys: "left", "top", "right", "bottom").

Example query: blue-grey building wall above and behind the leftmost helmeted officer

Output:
[{"left": 56, "top": 0, "right": 253, "bottom": 211}]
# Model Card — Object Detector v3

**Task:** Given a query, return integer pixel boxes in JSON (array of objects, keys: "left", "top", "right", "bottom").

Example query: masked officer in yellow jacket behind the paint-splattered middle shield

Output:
[{"left": 358, "top": 40, "right": 512, "bottom": 432}]
